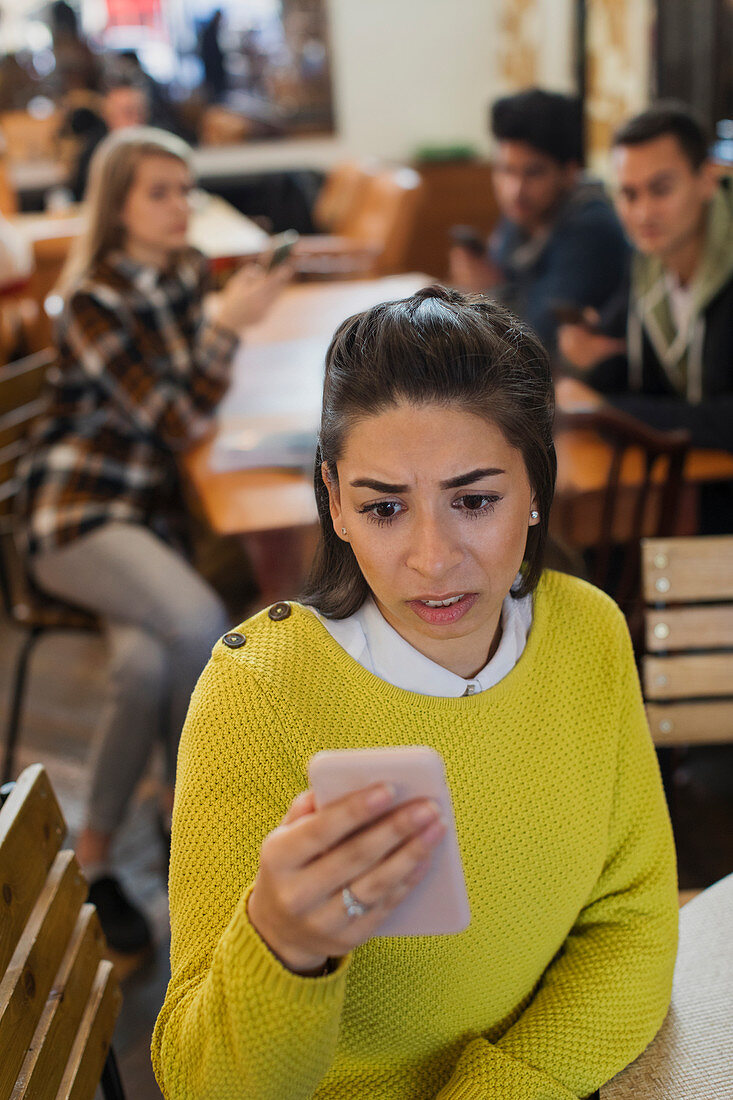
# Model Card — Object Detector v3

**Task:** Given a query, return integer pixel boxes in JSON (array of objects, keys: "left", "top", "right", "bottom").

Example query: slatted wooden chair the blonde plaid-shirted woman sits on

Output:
[{"left": 0, "top": 351, "right": 98, "bottom": 783}]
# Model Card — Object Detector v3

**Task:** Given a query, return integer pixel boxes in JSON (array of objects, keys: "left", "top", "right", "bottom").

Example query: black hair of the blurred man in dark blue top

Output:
[{"left": 491, "top": 88, "right": 583, "bottom": 165}]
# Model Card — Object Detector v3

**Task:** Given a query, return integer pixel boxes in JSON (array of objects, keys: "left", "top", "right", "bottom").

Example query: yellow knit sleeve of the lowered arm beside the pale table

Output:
[{"left": 431, "top": 624, "right": 677, "bottom": 1100}]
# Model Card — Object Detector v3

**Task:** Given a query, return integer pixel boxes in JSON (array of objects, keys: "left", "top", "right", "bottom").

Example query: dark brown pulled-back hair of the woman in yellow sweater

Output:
[{"left": 302, "top": 286, "right": 557, "bottom": 618}]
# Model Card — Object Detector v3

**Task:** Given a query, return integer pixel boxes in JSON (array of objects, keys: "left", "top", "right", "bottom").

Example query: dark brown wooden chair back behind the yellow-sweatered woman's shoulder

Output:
[{"left": 556, "top": 405, "right": 690, "bottom": 644}]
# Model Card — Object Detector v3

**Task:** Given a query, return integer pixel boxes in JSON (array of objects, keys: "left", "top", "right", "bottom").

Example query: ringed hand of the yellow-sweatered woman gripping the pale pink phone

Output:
[{"left": 249, "top": 784, "right": 446, "bottom": 974}]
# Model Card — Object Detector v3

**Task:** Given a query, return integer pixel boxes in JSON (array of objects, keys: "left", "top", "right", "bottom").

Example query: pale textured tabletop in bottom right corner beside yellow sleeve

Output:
[{"left": 601, "top": 875, "right": 733, "bottom": 1100}]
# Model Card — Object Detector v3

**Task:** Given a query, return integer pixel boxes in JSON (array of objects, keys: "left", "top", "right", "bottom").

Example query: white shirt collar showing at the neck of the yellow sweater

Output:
[{"left": 311, "top": 595, "right": 532, "bottom": 699}]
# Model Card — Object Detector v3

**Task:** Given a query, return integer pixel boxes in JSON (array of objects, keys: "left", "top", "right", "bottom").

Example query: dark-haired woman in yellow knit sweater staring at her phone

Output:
[{"left": 153, "top": 287, "right": 677, "bottom": 1100}]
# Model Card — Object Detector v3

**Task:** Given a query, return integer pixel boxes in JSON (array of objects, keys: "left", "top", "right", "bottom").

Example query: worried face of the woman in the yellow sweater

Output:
[{"left": 324, "top": 404, "right": 538, "bottom": 678}]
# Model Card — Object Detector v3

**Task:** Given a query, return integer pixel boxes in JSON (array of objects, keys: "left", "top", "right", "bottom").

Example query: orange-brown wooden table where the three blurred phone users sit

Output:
[{"left": 183, "top": 283, "right": 733, "bottom": 603}]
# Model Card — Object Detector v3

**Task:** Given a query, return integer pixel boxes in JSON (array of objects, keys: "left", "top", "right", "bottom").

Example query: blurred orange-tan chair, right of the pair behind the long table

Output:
[{"left": 295, "top": 167, "right": 423, "bottom": 278}]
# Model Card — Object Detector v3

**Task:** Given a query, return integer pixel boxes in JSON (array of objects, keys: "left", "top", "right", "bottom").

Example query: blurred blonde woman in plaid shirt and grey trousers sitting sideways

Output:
[{"left": 19, "top": 129, "right": 285, "bottom": 952}]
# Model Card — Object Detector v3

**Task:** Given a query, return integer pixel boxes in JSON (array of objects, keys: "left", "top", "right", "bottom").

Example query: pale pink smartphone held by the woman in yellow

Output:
[{"left": 308, "top": 745, "right": 471, "bottom": 936}]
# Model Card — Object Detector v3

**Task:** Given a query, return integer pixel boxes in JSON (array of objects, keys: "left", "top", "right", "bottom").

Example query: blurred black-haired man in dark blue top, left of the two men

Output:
[{"left": 450, "top": 88, "right": 627, "bottom": 350}]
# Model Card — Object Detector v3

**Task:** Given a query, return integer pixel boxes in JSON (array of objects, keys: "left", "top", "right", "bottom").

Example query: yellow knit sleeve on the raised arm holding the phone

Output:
[{"left": 152, "top": 644, "right": 349, "bottom": 1100}]
